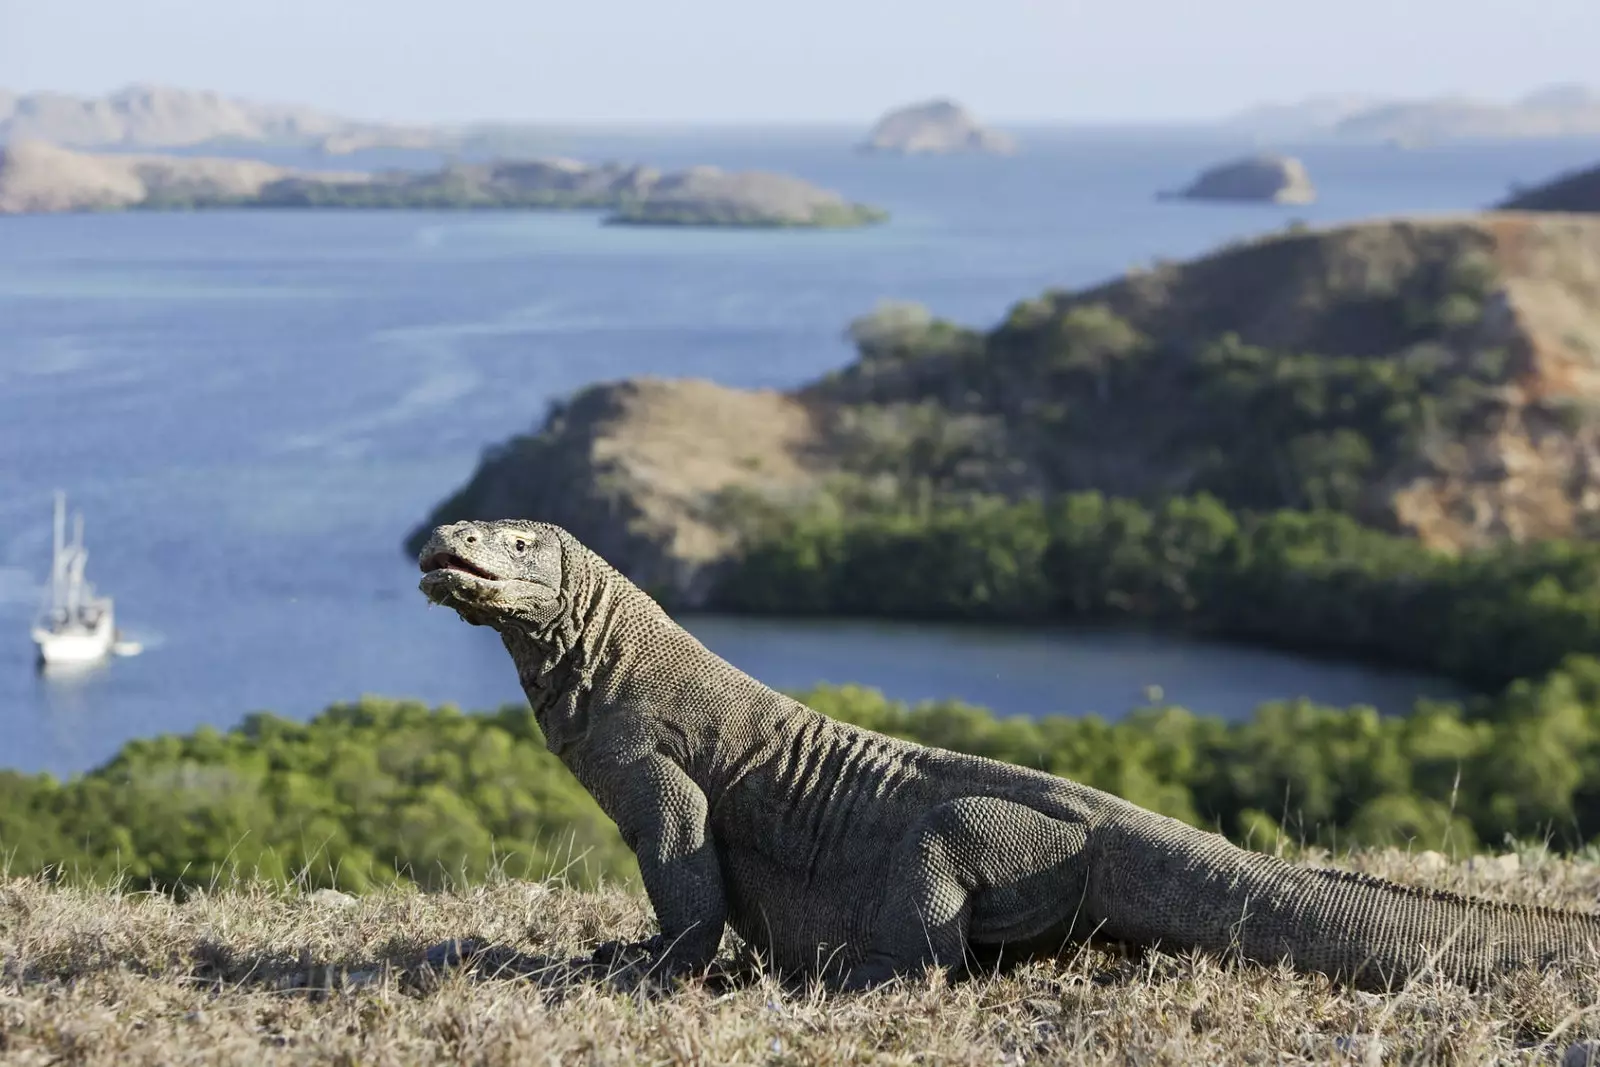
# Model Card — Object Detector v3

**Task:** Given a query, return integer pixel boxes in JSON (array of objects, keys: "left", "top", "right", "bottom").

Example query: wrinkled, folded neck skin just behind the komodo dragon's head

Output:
[{"left": 501, "top": 541, "right": 637, "bottom": 757}]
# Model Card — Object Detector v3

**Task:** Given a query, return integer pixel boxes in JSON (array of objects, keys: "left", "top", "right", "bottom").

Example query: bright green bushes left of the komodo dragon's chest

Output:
[{"left": 0, "top": 701, "right": 632, "bottom": 891}]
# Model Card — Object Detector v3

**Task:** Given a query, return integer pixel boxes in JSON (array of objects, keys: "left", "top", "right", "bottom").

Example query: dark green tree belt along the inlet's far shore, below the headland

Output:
[{"left": 714, "top": 491, "right": 1600, "bottom": 691}]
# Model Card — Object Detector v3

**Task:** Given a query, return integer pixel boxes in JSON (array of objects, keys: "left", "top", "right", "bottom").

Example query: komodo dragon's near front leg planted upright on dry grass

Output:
[{"left": 590, "top": 755, "right": 728, "bottom": 974}]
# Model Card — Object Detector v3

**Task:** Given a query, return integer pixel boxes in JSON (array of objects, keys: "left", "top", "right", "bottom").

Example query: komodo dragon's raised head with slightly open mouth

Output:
[{"left": 418, "top": 518, "right": 565, "bottom": 633}]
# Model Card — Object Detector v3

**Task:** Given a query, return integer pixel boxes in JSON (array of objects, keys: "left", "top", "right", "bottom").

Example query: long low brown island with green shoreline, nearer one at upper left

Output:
[{"left": 0, "top": 141, "right": 886, "bottom": 227}]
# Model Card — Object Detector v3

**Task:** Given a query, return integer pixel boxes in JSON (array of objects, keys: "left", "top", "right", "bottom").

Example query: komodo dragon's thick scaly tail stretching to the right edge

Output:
[{"left": 1090, "top": 816, "right": 1600, "bottom": 989}]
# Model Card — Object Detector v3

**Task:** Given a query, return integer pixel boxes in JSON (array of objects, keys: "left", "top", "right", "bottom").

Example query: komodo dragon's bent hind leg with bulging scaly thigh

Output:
[{"left": 842, "top": 797, "right": 1088, "bottom": 990}]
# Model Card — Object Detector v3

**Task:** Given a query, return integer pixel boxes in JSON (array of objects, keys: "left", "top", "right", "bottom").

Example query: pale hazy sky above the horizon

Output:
[{"left": 0, "top": 0, "right": 1600, "bottom": 122}]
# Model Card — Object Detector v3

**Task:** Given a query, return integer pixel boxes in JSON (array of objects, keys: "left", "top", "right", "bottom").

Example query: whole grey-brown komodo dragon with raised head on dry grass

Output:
[{"left": 421, "top": 522, "right": 1600, "bottom": 989}]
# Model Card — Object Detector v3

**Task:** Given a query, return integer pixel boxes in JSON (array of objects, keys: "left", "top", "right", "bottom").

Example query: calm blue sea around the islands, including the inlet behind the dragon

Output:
[{"left": 0, "top": 131, "right": 1600, "bottom": 773}]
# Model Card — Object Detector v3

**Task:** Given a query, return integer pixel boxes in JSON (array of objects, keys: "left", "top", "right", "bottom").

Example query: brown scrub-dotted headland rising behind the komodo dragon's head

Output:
[{"left": 419, "top": 213, "right": 1600, "bottom": 603}]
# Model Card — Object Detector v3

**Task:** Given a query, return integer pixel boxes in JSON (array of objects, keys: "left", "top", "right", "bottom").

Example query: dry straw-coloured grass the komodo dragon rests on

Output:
[{"left": 9, "top": 853, "right": 1600, "bottom": 1065}]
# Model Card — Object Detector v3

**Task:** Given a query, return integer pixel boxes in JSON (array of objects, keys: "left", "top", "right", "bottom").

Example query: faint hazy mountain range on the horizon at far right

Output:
[{"left": 1222, "top": 85, "right": 1600, "bottom": 144}]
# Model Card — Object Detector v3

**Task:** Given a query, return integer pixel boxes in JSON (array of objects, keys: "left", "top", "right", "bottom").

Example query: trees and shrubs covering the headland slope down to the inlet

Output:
[{"left": 714, "top": 271, "right": 1580, "bottom": 691}]
